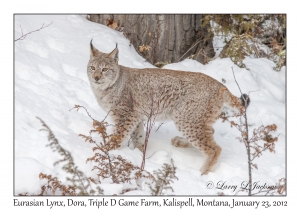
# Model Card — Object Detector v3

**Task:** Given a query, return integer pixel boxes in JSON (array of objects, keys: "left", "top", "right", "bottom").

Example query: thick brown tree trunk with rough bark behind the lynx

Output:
[{"left": 88, "top": 14, "right": 215, "bottom": 64}]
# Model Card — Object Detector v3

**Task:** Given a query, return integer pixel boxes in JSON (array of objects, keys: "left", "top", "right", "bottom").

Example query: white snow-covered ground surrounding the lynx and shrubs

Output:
[{"left": 14, "top": 15, "right": 286, "bottom": 195}]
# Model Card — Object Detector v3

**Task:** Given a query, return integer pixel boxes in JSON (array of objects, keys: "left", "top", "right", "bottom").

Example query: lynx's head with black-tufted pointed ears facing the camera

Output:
[{"left": 87, "top": 40, "right": 120, "bottom": 90}]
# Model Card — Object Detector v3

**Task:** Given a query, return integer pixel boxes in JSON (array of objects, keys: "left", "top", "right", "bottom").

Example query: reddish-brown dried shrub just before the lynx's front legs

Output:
[{"left": 75, "top": 105, "right": 152, "bottom": 184}]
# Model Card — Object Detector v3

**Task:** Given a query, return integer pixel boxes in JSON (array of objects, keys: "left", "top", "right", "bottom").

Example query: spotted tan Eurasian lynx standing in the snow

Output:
[{"left": 87, "top": 41, "right": 250, "bottom": 174}]
